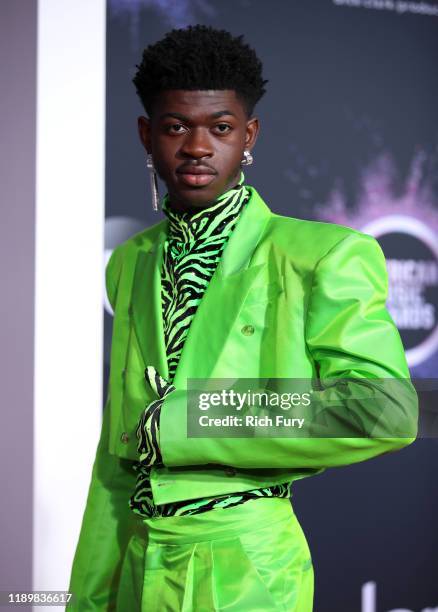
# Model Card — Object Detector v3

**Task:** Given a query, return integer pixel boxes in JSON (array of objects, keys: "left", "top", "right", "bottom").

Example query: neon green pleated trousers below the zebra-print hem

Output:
[{"left": 116, "top": 498, "right": 313, "bottom": 612}]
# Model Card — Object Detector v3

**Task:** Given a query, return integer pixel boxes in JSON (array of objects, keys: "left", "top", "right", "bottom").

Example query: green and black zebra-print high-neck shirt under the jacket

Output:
[{"left": 129, "top": 172, "right": 290, "bottom": 518}]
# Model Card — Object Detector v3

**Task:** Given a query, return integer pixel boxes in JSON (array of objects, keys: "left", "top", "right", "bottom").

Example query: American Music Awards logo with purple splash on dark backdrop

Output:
[{"left": 317, "top": 151, "right": 438, "bottom": 366}]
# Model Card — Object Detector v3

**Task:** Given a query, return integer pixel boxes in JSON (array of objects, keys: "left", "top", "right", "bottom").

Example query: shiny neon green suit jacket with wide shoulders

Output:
[{"left": 69, "top": 187, "right": 418, "bottom": 612}]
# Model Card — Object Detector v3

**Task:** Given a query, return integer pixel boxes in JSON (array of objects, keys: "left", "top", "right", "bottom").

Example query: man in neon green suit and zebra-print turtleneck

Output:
[{"left": 68, "top": 26, "right": 417, "bottom": 612}]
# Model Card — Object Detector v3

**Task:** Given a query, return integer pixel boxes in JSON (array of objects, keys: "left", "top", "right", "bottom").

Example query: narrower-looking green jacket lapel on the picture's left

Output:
[{"left": 132, "top": 220, "right": 169, "bottom": 378}]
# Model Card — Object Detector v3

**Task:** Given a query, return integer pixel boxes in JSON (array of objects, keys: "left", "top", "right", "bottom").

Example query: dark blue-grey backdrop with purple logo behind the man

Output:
[{"left": 104, "top": 0, "right": 438, "bottom": 612}]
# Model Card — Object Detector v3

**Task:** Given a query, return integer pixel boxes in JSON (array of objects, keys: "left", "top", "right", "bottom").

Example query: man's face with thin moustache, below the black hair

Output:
[{"left": 138, "top": 90, "right": 259, "bottom": 210}]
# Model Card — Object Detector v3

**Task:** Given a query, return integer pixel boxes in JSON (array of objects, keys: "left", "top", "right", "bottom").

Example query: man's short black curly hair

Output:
[{"left": 132, "top": 24, "right": 268, "bottom": 117}]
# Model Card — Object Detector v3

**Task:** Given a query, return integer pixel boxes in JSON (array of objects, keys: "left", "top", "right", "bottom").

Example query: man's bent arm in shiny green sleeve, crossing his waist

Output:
[{"left": 160, "top": 232, "right": 418, "bottom": 468}]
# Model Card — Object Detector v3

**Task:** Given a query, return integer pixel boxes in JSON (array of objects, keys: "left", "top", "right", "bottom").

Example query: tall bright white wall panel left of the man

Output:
[{"left": 33, "top": 0, "right": 106, "bottom": 610}]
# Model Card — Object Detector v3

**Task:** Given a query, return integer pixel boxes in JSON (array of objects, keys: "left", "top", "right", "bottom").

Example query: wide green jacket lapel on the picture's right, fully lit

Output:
[{"left": 174, "top": 187, "right": 272, "bottom": 388}]
